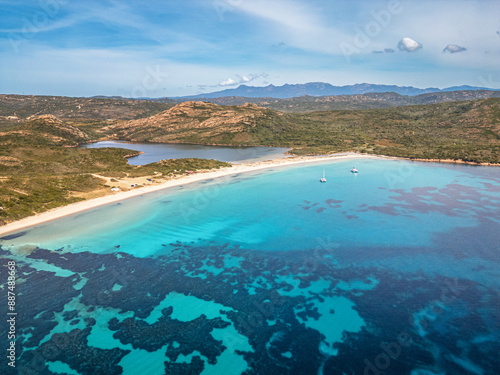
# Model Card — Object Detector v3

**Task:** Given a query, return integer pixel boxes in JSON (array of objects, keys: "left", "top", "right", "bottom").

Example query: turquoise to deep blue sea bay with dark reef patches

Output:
[{"left": 0, "top": 159, "right": 500, "bottom": 375}]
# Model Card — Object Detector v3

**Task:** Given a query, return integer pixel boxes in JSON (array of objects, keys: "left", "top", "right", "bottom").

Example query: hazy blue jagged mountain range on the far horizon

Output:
[{"left": 175, "top": 82, "right": 500, "bottom": 100}]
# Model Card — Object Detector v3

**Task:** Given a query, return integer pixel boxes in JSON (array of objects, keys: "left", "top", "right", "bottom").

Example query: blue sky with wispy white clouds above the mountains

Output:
[{"left": 0, "top": 0, "right": 500, "bottom": 97}]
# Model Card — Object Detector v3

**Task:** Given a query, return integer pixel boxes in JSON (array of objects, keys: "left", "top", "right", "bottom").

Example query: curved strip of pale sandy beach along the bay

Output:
[{"left": 0, "top": 153, "right": 378, "bottom": 235}]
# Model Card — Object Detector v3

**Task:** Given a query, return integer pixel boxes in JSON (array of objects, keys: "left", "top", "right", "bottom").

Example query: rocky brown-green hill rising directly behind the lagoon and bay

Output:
[{"left": 108, "top": 98, "right": 500, "bottom": 163}]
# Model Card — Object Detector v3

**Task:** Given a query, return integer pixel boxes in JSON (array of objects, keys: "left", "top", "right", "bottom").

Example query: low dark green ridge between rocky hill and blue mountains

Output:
[{"left": 0, "top": 90, "right": 500, "bottom": 120}]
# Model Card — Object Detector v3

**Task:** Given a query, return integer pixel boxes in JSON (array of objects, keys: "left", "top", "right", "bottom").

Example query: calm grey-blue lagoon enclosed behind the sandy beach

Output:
[{"left": 80, "top": 141, "right": 289, "bottom": 165}]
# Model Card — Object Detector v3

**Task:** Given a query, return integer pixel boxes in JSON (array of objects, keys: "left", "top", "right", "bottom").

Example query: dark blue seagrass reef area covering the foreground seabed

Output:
[{"left": 0, "top": 235, "right": 500, "bottom": 375}]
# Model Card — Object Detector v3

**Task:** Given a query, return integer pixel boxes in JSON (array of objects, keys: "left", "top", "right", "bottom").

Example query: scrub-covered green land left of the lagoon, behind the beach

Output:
[{"left": 0, "top": 116, "right": 230, "bottom": 225}]
